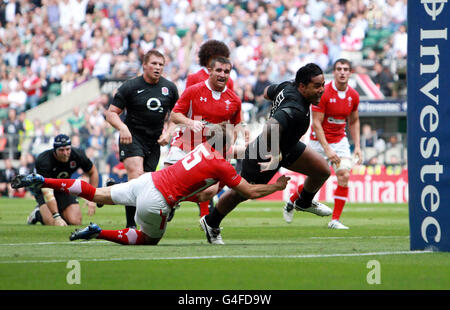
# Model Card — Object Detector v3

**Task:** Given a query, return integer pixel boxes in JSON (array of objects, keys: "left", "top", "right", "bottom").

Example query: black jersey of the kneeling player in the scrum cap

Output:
[{"left": 35, "top": 147, "right": 93, "bottom": 179}]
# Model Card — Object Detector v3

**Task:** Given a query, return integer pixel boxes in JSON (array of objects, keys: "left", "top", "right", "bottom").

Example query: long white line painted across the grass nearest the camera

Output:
[{"left": 0, "top": 251, "right": 433, "bottom": 264}]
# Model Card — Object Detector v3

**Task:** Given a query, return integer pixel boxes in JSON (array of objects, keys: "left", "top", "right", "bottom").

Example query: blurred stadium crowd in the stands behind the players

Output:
[{"left": 0, "top": 0, "right": 407, "bottom": 196}]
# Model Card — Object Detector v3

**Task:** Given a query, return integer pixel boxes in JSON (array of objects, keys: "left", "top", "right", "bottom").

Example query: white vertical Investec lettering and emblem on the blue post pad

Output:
[{"left": 418, "top": 0, "right": 448, "bottom": 243}]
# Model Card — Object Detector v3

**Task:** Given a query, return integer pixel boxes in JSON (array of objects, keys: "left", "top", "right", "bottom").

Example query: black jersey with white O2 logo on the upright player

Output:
[{"left": 112, "top": 75, "right": 179, "bottom": 140}]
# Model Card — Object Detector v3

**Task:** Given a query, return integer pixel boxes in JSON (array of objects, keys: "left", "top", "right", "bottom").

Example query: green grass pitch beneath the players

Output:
[{"left": 0, "top": 199, "right": 450, "bottom": 290}]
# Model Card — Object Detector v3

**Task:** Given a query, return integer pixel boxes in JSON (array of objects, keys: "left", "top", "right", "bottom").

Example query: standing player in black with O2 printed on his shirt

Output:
[{"left": 106, "top": 50, "right": 179, "bottom": 227}]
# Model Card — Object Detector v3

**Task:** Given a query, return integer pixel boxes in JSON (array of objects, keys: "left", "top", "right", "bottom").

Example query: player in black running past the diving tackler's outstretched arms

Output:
[{"left": 200, "top": 63, "right": 332, "bottom": 245}]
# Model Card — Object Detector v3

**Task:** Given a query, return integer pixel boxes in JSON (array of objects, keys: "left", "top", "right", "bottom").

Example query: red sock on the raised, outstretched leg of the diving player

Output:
[{"left": 43, "top": 178, "right": 96, "bottom": 201}]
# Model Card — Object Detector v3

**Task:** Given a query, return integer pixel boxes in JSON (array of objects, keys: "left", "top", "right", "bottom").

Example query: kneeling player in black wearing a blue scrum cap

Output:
[{"left": 28, "top": 134, "right": 98, "bottom": 226}]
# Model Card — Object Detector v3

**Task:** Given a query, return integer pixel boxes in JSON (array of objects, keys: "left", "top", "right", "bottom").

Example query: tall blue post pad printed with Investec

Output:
[{"left": 407, "top": 0, "right": 450, "bottom": 251}]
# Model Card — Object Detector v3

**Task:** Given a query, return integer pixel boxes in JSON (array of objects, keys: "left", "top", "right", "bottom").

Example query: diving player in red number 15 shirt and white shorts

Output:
[{"left": 11, "top": 123, "right": 289, "bottom": 245}]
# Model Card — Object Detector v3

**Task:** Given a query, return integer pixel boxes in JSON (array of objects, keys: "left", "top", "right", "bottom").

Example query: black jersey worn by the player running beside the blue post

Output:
[{"left": 267, "top": 81, "right": 310, "bottom": 153}]
